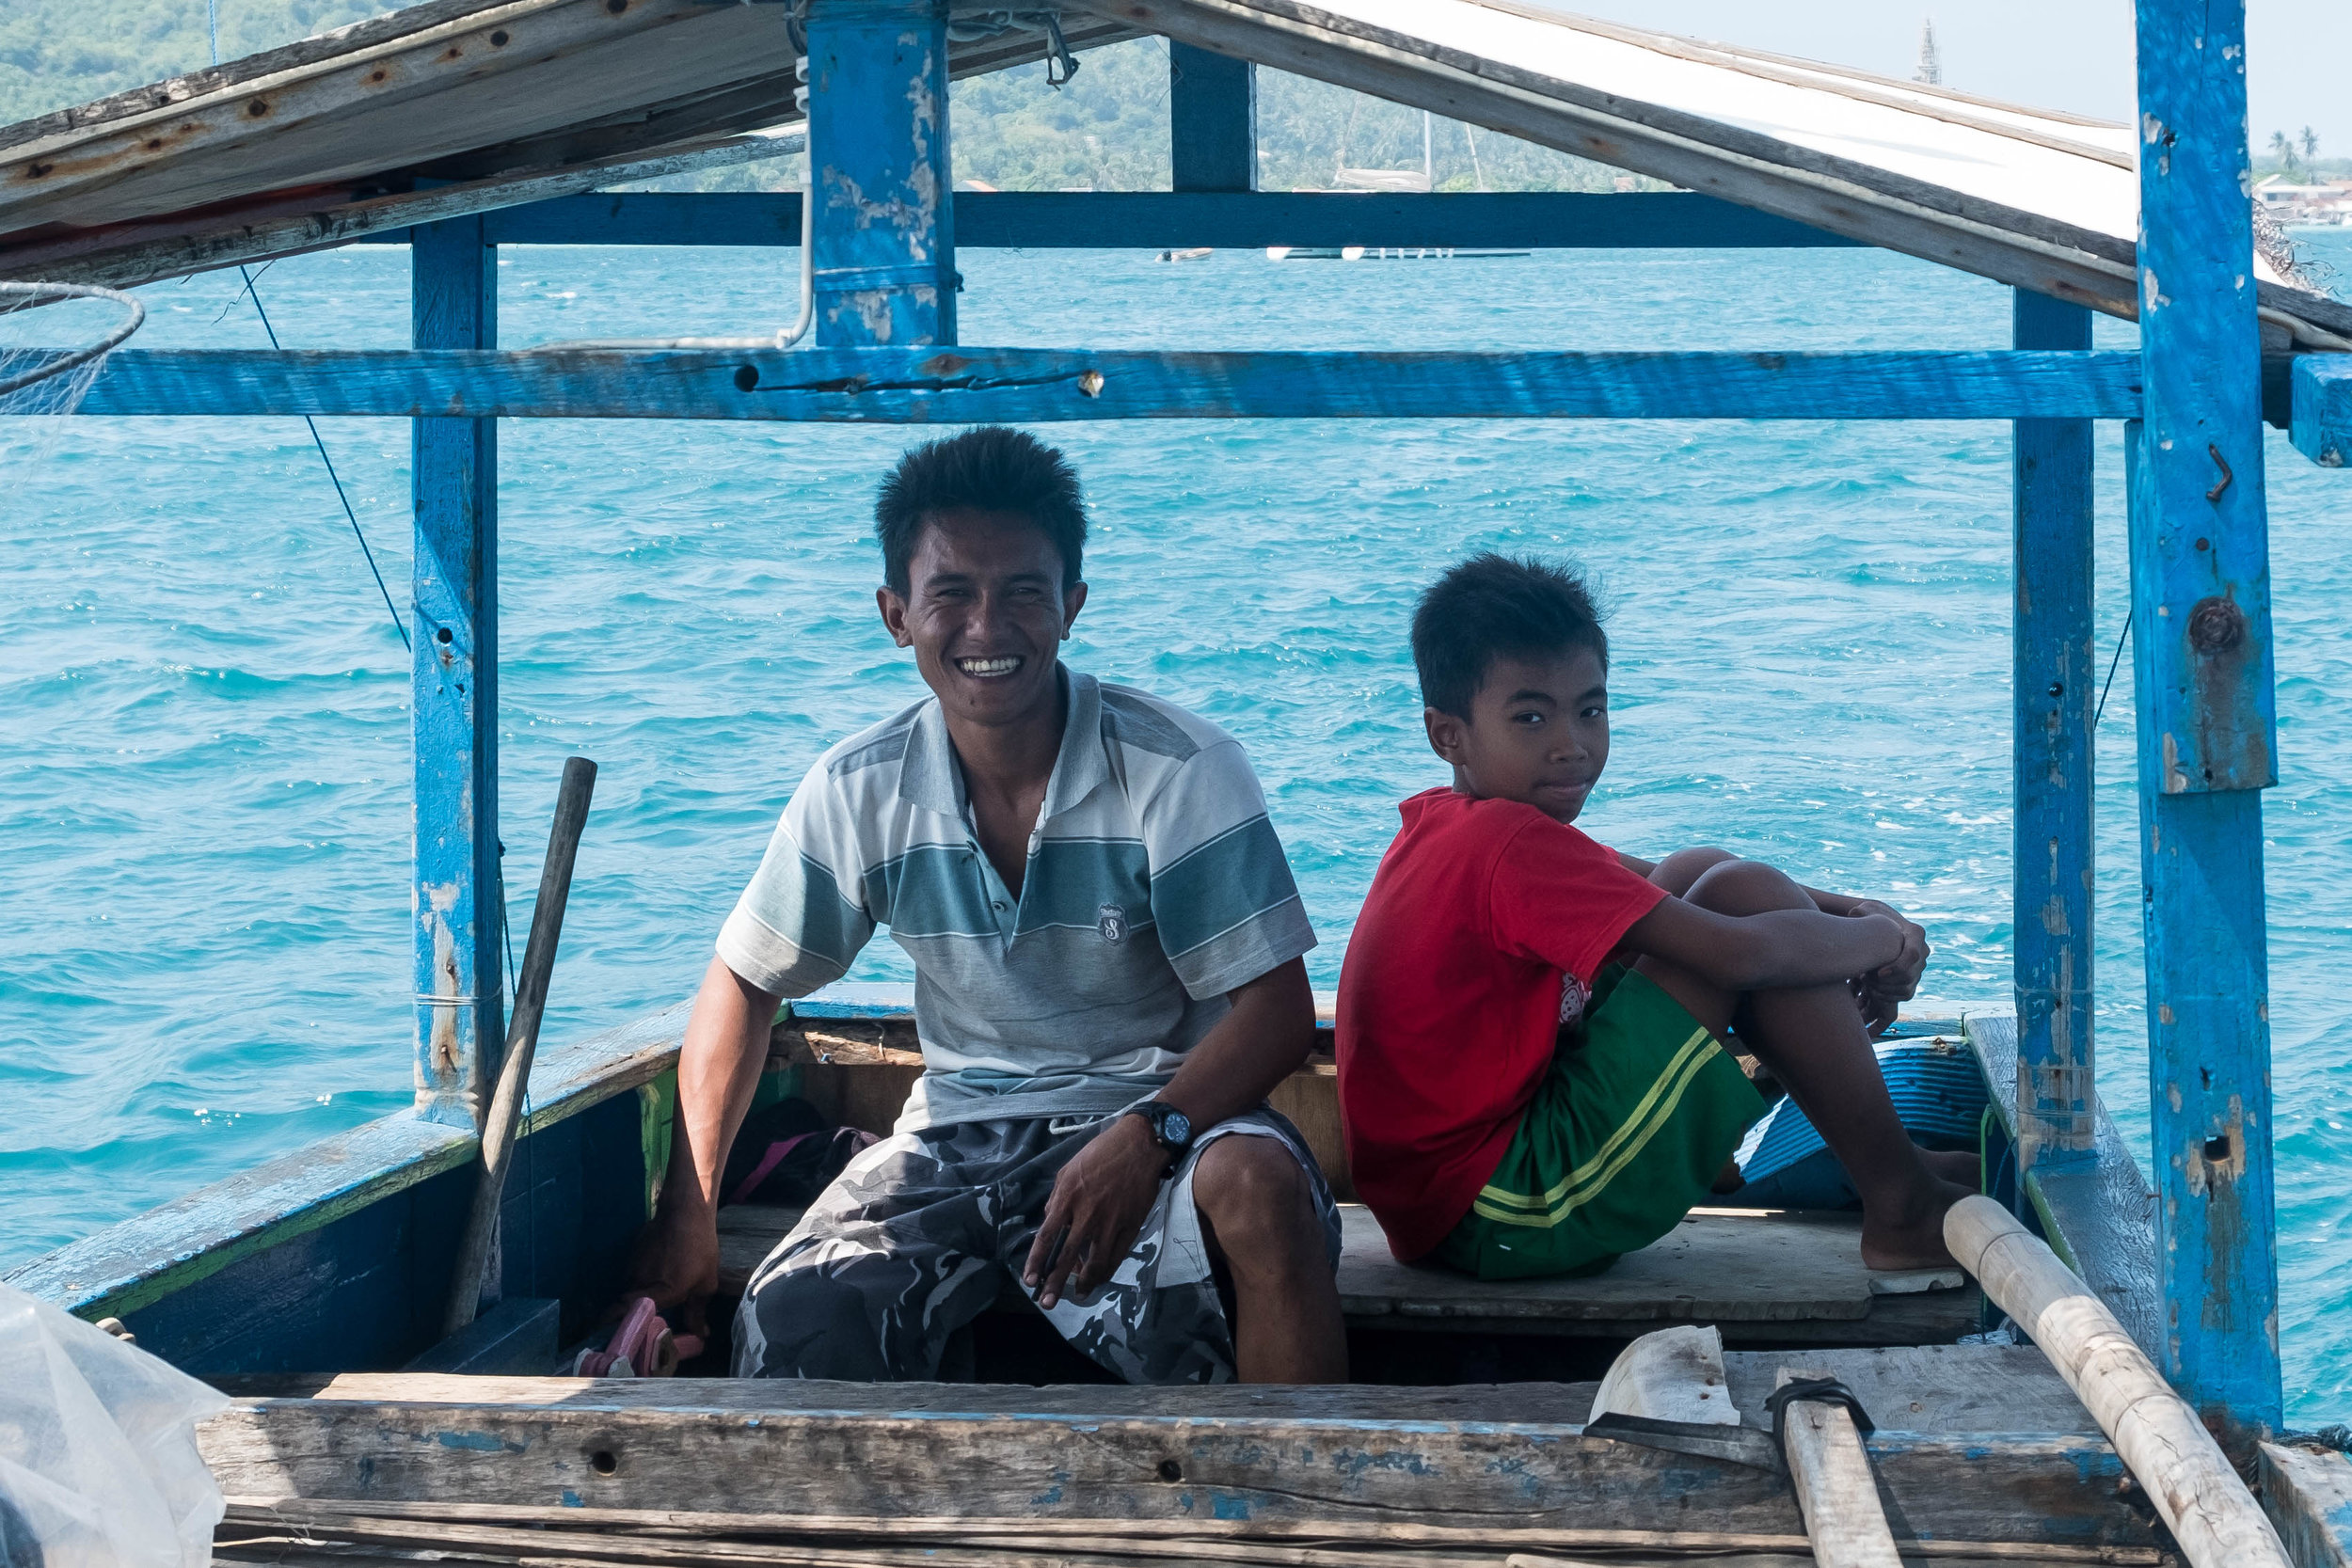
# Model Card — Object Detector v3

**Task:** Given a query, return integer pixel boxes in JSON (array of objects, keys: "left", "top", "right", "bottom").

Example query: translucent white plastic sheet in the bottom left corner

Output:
[{"left": 0, "top": 1284, "right": 229, "bottom": 1568}]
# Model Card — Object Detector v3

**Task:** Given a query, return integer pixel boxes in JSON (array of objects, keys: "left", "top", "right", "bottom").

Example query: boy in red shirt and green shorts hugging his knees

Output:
[{"left": 1339, "top": 555, "right": 1974, "bottom": 1279}]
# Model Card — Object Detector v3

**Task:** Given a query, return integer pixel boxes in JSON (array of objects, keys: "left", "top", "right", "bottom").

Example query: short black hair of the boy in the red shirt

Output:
[{"left": 1414, "top": 550, "right": 1609, "bottom": 720}]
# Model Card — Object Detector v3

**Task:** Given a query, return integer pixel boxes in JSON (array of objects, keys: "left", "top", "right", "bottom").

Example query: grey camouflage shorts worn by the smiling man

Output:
[{"left": 734, "top": 1107, "right": 1339, "bottom": 1383}]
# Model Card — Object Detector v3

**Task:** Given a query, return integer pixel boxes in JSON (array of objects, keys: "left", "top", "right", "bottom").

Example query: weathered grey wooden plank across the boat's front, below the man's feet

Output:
[{"left": 200, "top": 1399, "right": 2153, "bottom": 1547}]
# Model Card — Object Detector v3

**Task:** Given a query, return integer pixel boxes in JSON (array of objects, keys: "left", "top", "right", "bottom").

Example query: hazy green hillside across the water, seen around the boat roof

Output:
[{"left": 0, "top": 0, "right": 1656, "bottom": 190}]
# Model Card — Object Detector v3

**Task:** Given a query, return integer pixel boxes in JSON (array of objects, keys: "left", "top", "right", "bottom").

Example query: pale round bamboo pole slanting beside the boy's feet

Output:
[{"left": 1943, "top": 1196, "right": 2294, "bottom": 1568}]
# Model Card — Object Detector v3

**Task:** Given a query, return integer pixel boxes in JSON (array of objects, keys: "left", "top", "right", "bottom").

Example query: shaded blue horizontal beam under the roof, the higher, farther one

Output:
[{"left": 419, "top": 190, "right": 1858, "bottom": 249}]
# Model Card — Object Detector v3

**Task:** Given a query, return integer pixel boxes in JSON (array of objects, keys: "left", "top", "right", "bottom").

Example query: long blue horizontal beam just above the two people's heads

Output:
[{"left": 80, "top": 348, "right": 2140, "bottom": 423}]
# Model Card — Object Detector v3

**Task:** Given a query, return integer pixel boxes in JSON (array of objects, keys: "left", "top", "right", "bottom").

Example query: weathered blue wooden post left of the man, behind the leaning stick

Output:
[{"left": 409, "top": 216, "right": 506, "bottom": 1126}]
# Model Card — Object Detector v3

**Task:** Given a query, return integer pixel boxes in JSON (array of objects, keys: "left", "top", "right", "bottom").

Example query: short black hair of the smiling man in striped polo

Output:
[{"left": 875, "top": 425, "right": 1087, "bottom": 594}]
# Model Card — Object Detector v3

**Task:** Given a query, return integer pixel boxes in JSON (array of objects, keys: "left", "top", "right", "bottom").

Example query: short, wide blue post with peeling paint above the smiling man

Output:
[{"left": 809, "top": 0, "right": 958, "bottom": 348}]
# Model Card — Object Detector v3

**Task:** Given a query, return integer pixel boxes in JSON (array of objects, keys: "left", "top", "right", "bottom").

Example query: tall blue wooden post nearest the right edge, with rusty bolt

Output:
[{"left": 2131, "top": 0, "right": 2280, "bottom": 1439}]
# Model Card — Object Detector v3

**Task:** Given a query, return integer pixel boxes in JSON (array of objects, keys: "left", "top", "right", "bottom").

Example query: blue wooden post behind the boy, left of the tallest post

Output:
[{"left": 2011, "top": 289, "right": 2098, "bottom": 1175}]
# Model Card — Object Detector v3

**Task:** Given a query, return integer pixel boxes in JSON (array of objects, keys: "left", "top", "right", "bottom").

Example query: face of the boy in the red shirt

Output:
[{"left": 1421, "top": 649, "right": 1609, "bottom": 823}]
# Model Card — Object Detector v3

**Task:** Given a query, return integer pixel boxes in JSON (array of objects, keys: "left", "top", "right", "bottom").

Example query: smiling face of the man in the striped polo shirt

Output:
[{"left": 875, "top": 508, "right": 1087, "bottom": 724}]
